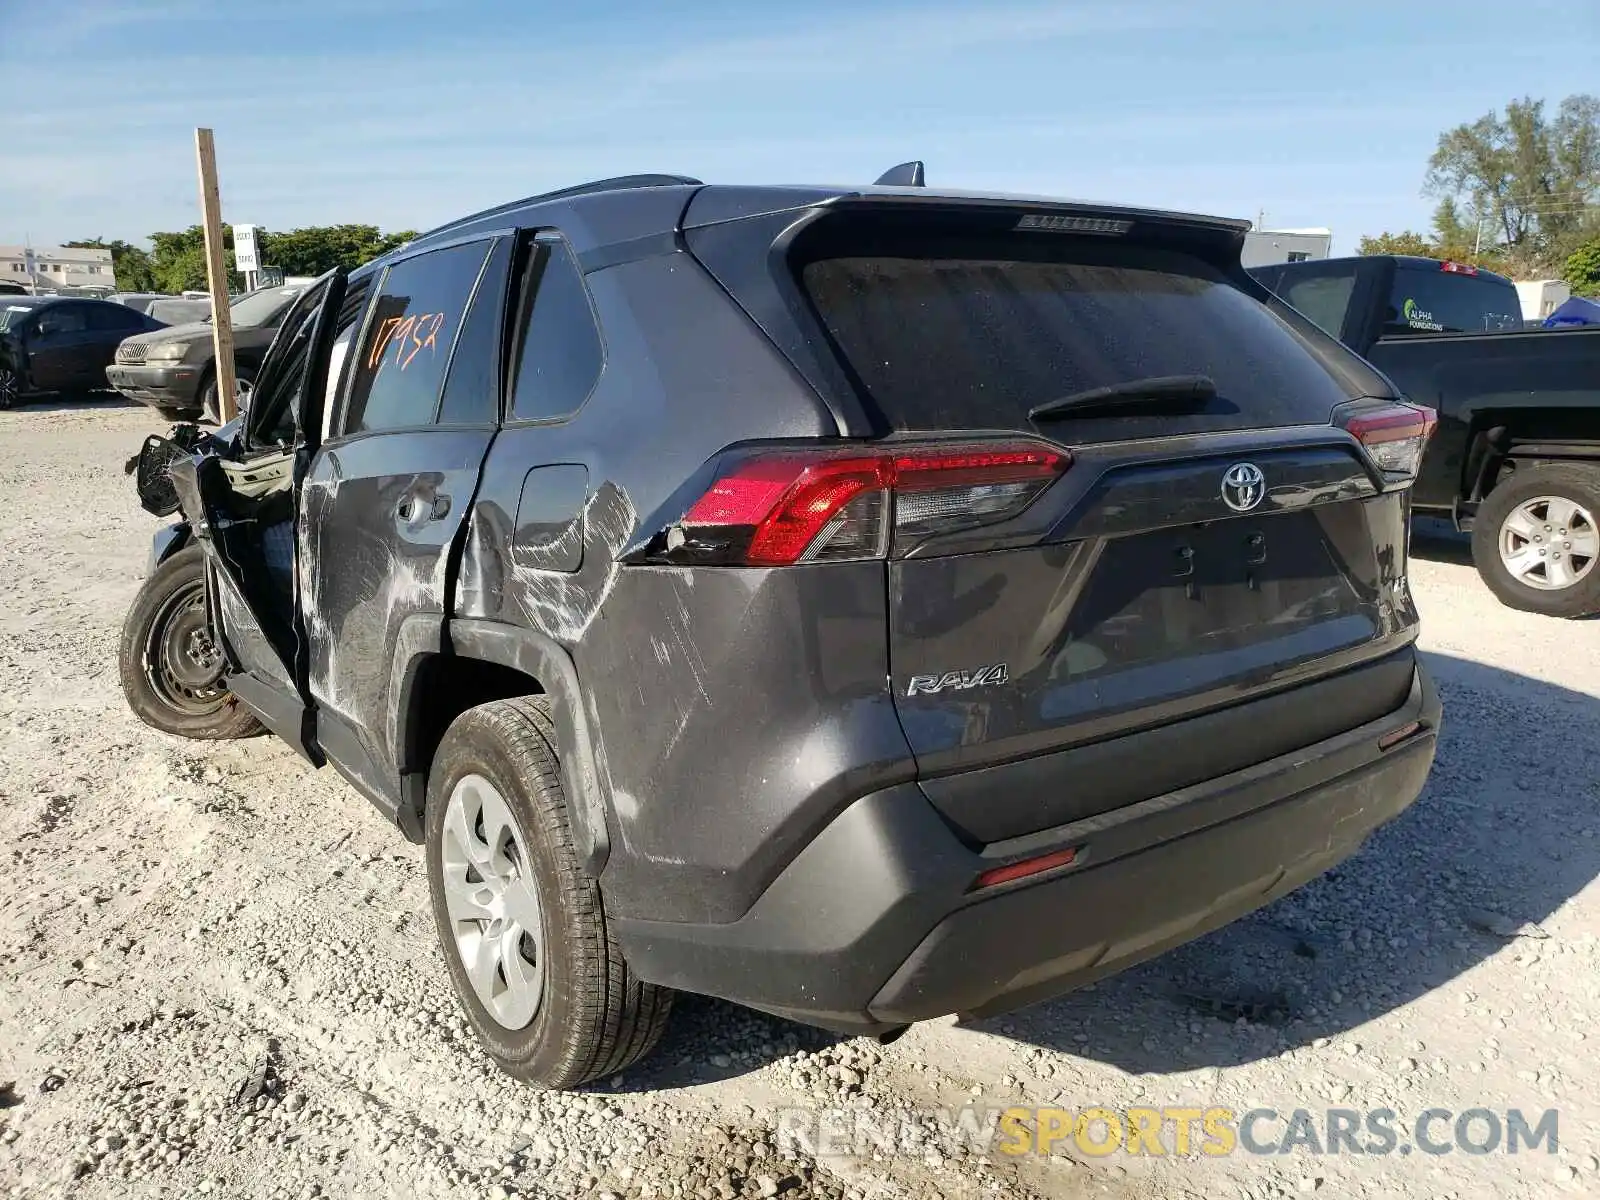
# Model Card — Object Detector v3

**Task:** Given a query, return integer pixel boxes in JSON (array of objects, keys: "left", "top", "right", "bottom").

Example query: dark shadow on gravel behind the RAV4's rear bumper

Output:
[{"left": 968, "top": 654, "right": 1600, "bottom": 1074}]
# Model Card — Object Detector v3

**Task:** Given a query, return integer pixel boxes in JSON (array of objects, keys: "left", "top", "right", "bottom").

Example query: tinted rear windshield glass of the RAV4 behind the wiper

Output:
[{"left": 800, "top": 238, "right": 1369, "bottom": 437}]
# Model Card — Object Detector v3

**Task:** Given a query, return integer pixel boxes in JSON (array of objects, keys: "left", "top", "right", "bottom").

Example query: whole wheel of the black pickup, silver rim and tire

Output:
[{"left": 1472, "top": 462, "right": 1600, "bottom": 618}]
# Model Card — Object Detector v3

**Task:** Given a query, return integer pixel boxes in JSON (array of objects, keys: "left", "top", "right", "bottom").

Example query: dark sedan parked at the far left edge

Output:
[{"left": 0, "top": 296, "right": 162, "bottom": 408}]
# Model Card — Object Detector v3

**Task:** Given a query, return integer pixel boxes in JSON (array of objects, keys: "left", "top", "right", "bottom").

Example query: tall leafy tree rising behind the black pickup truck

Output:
[{"left": 1424, "top": 94, "right": 1600, "bottom": 272}]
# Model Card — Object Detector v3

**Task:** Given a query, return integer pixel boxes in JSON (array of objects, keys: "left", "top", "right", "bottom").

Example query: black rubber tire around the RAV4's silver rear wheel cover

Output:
[{"left": 426, "top": 696, "right": 674, "bottom": 1088}]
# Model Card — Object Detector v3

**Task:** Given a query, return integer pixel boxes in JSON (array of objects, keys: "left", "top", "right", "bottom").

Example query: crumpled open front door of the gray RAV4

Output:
[{"left": 171, "top": 270, "right": 344, "bottom": 765}]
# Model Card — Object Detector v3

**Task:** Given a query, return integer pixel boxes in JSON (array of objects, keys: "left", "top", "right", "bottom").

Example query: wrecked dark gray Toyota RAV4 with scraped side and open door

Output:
[{"left": 122, "top": 176, "right": 1440, "bottom": 1086}]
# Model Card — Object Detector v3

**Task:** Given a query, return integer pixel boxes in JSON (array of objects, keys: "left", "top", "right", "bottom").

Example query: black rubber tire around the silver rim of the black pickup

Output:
[{"left": 1472, "top": 462, "right": 1600, "bottom": 618}]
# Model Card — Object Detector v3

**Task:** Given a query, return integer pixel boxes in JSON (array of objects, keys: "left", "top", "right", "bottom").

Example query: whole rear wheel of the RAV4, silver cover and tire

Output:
[{"left": 426, "top": 696, "right": 672, "bottom": 1088}]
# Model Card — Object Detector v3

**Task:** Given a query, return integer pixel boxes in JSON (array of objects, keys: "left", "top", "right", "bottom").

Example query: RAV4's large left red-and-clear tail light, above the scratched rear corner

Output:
[{"left": 666, "top": 442, "right": 1072, "bottom": 566}]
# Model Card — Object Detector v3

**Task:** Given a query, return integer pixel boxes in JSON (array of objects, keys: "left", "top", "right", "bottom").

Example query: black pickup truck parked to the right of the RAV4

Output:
[{"left": 1251, "top": 254, "right": 1600, "bottom": 616}]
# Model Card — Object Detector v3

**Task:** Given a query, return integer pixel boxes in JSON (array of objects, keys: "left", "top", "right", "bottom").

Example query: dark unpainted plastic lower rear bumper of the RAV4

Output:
[{"left": 614, "top": 666, "right": 1440, "bottom": 1032}]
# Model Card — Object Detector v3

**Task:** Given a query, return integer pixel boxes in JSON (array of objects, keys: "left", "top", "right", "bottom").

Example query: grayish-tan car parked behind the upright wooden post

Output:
[{"left": 106, "top": 285, "right": 304, "bottom": 421}]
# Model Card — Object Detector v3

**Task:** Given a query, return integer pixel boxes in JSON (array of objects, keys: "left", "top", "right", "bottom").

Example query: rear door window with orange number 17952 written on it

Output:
[{"left": 344, "top": 242, "right": 488, "bottom": 434}]
